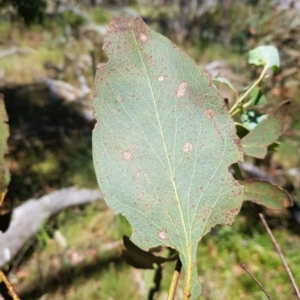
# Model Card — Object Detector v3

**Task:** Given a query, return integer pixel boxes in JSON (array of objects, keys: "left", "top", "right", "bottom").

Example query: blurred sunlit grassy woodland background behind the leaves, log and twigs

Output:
[{"left": 0, "top": 0, "right": 300, "bottom": 300}]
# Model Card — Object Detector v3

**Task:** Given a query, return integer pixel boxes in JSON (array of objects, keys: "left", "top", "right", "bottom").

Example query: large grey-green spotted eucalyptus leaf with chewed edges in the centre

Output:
[{"left": 93, "top": 17, "right": 243, "bottom": 299}]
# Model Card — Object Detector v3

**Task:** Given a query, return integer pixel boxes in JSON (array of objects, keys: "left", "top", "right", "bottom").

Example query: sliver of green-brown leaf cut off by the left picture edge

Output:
[{"left": 0, "top": 94, "right": 10, "bottom": 206}]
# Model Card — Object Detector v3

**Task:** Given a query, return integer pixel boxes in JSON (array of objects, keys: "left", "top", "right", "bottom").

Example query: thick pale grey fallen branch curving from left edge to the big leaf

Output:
[{"left": 0, "top": 188, "right": 102, "bottom": 268}]
